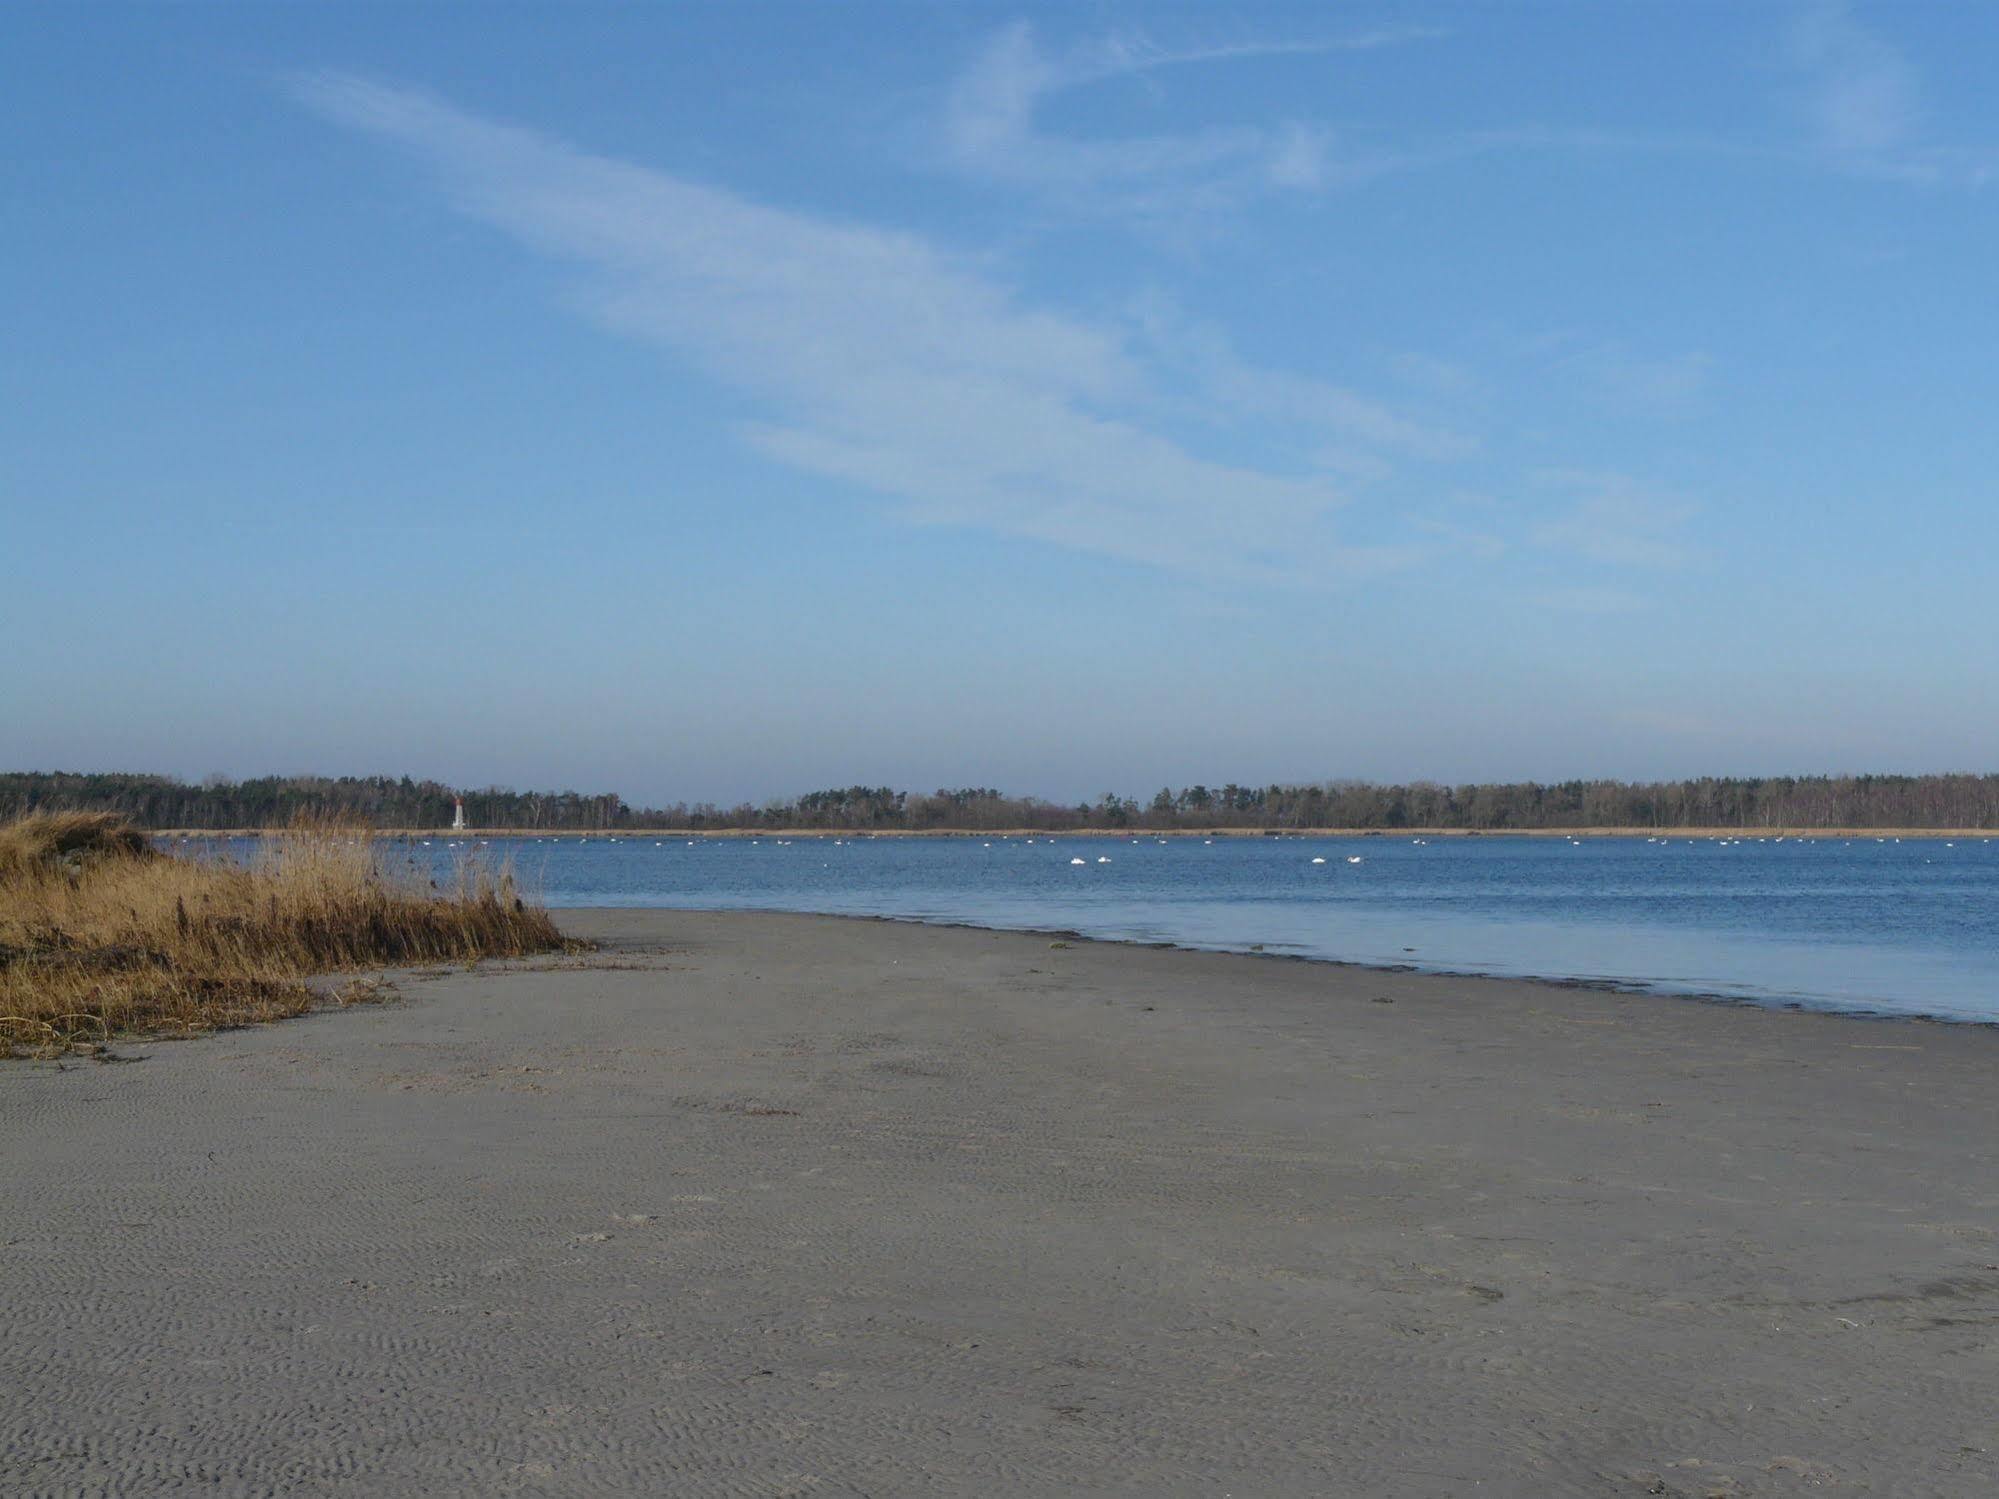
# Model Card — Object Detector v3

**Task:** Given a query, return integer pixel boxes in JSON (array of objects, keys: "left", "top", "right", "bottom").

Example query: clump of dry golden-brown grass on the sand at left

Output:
[{"left": 0, "top": 813, "right": 570, "bottom": 1055}]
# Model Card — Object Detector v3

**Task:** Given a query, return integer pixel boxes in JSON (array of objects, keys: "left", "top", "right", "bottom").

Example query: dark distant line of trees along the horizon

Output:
[{"left": 0, "top": 771, "right": 1999, "bottom": 831}]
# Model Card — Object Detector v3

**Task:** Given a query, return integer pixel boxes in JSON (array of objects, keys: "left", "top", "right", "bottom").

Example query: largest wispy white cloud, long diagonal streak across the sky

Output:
[{"left": 294, "top": 74, "right": 1429, "bottom": 578}]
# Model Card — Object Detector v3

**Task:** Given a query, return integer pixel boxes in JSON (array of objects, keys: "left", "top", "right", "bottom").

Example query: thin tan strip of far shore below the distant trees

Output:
[{"left": 155, "top": 827, "right": 1999, "bottom": 841}]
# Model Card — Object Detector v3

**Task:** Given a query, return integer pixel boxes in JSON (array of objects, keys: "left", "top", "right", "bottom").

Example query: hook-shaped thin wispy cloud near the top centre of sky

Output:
[{"left": 944, "top": 22, "right": 1441, "bottom": 216}]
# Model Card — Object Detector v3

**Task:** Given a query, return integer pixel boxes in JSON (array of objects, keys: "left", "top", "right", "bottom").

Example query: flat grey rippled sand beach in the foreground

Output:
[{"left": 11, "top": 911, "right": 1999, "bottom": 1497}]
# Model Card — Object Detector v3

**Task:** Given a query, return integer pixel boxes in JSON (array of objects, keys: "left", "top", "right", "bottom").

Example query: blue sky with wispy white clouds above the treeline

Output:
[{"left": 0, "top": 0, "right": 1999, "bottom": 803}]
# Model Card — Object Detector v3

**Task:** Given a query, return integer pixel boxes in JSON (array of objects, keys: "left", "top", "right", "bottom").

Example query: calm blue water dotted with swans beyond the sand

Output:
[{"left": 327, "top": 835, "right": 1999, "bottom": 1021}]
